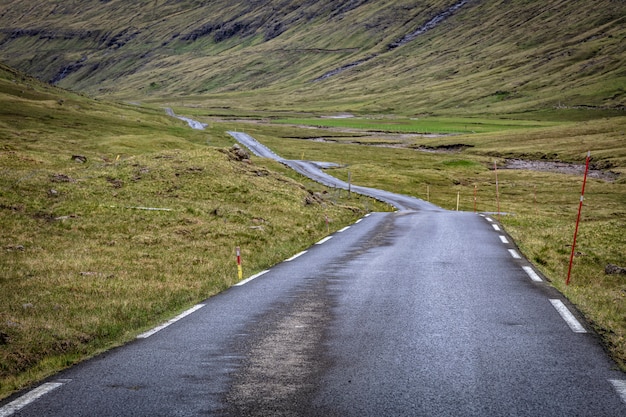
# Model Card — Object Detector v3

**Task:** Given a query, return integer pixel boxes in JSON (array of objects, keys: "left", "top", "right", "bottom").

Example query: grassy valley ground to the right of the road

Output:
[{"left": 196, "top": 110, "right": 626, "bottom": 369}]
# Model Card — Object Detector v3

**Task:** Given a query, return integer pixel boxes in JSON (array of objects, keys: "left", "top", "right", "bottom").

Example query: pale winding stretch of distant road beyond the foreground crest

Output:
[{"left": 228, "top": 132, "right": 442, "bottom": 211}]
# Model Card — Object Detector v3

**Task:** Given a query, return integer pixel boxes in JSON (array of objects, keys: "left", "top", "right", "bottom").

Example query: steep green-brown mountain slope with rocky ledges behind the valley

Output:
[{"left": 0, "top": 0, "right": 626, "bottom": 113}]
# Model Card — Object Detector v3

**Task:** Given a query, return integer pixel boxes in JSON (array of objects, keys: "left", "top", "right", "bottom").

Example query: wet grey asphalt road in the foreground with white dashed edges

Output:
[{"left": 0, "top": 132, "right": 626, "bottom": 417}]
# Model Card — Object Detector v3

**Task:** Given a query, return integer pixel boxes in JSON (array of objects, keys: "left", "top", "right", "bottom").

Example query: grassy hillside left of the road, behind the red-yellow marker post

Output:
[{"left": 0, "top": 69, "right": 386, "bottom": 398}]
